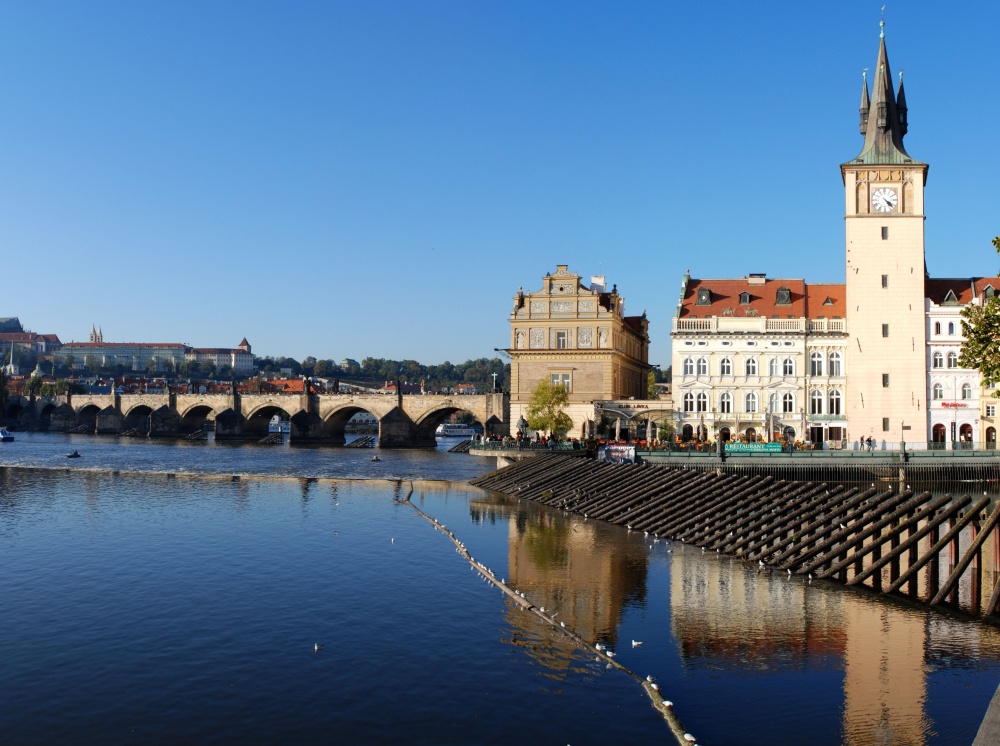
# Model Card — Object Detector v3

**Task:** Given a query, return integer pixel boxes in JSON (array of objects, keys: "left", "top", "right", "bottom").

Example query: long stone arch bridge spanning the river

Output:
[{"left": 22, "top": 393, "right": 510, "bottom": 448}]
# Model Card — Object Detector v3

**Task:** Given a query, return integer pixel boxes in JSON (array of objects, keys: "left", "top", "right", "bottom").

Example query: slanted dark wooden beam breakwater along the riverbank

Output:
[{"left": 471, "top": 455, "right": 1000, "bottom": 616}]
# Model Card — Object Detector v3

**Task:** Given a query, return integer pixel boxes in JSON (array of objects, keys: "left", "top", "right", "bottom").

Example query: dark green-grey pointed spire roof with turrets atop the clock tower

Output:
[{"left": 844, "top": 21, "right": 925, "bottom": 166}]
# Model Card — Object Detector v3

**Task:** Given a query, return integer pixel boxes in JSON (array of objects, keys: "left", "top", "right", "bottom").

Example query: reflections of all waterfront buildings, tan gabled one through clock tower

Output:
[{"left": 470, "top": 486, "right": 1000, "bottom": 744}]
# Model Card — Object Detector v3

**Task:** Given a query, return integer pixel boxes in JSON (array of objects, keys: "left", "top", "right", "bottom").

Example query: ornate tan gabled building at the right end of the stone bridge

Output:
[{"left": 507, "top": 264, "right": 649, "bottom": 437}]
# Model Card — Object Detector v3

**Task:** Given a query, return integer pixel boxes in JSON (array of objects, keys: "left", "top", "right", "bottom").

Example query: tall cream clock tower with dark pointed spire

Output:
[{"left": 840, "top": 21, "right": 927, "bottom": 447}]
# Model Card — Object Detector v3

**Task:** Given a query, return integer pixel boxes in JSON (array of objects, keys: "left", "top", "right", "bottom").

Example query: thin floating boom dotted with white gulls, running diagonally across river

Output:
[{"left": 397, "top": 482, "right": 695, "bottom": 746}]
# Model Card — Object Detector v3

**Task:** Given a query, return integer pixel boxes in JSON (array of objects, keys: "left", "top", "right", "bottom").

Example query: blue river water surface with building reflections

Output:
[{"left": 0, "top": 433, "right": 1000, "bottom": 745}]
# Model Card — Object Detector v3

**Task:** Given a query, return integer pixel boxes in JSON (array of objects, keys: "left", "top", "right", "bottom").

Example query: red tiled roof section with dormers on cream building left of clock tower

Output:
[{"left": 680, "top": 277, "right": 806, "bottom": 319}]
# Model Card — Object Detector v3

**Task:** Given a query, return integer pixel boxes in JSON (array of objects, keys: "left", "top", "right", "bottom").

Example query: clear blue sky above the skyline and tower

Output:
[{"left": 0, "top": 0, "right": 1000, "bottom": 365}]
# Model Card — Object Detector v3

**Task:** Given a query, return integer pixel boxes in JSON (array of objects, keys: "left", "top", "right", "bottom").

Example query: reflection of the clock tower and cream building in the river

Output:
[{"left": 670, "top": 547, "right": 1000, "bottom": 744}]
